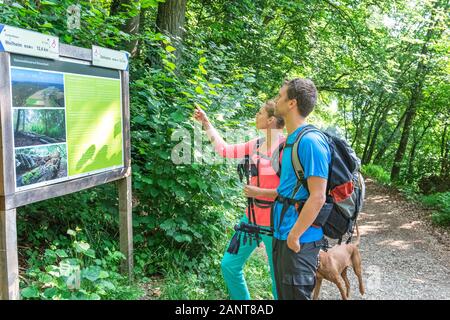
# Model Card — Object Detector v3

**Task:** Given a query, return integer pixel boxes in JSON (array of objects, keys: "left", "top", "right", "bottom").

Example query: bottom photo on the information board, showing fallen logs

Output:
[{"left": 16, "top": 144, "right": 67, "bottom": 187}]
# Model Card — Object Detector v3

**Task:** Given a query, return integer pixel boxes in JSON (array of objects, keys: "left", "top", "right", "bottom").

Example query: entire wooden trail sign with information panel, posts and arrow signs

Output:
[{"left": 0, "top": 25, "right": 133, "bottom": 300}]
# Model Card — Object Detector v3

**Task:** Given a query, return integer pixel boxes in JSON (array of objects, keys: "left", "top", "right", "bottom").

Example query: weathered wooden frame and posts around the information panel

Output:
[{"left": 0, "top": 44, "right": 133, "bottom": 300}]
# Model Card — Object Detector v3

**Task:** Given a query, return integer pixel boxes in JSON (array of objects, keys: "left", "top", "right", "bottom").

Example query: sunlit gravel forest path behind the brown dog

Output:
[{"left": 319, "top": 180, "right": 450, "bottom": 300}]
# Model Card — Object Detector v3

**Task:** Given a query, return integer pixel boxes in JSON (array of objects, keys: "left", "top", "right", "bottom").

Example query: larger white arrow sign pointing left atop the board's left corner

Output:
[{"left": 0, "top": 24, "right": 59, "bottom": 60}]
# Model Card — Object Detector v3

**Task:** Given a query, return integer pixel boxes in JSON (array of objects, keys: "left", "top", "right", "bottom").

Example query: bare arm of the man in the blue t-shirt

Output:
[{"left": 287, "top": 177, "right": 327, "bottom": 252}]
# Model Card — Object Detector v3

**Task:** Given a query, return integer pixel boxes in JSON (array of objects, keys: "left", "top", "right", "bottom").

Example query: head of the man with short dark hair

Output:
[{"left": 275, "top": 78, "right": 317, "bottom": 118}]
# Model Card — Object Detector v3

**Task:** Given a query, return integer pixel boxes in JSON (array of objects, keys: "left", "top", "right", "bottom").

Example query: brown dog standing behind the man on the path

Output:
[{"left": 313, "top": 225, "right": 364, "bottom": 300}]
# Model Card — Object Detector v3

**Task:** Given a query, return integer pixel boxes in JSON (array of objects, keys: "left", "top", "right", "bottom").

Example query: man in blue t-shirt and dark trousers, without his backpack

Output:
[{"left": 272, "top": 78, "right": 331, "bottom": 300}]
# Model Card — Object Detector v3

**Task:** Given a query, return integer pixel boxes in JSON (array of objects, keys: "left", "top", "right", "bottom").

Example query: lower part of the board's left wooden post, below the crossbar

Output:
[{"left": 0, "top": 209, "right": 20, "bottom": 300}]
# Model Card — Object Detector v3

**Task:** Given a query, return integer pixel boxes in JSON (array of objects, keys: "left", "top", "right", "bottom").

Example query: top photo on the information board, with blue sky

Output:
[{"left": 11, "top": 68, "right": 65, "bottom": 108}]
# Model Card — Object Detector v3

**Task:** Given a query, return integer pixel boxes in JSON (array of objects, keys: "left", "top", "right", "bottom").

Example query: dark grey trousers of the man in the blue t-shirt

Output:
[{"left": 272, "top": 238, "right": 322, "bottom": 300}]
